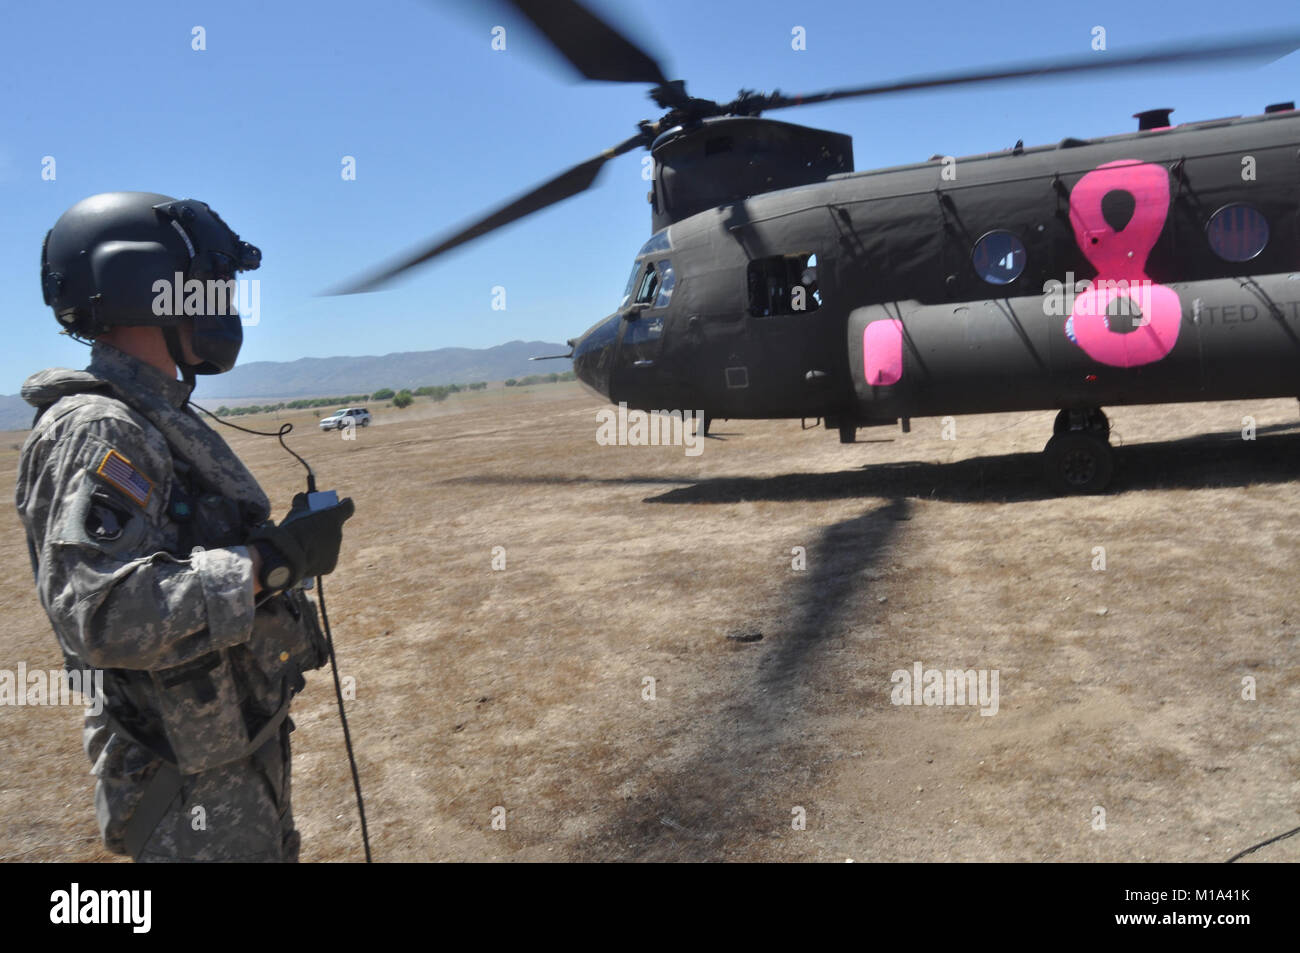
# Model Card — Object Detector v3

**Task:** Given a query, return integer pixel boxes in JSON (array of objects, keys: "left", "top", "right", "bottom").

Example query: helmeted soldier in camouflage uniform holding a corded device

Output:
[{"left": 17, "top": 192, "right": 352, "bottom": 861}]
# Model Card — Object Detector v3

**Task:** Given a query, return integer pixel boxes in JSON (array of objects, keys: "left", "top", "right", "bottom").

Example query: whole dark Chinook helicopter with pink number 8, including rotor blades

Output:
[{"left": 332, "top": 0, "right": 1300, "bottom": 491}]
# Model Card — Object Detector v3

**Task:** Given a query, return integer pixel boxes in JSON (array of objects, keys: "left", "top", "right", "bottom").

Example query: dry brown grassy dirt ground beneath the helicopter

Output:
[{"left": 0, "top": 385, "right": 1300, "bottom": 861}]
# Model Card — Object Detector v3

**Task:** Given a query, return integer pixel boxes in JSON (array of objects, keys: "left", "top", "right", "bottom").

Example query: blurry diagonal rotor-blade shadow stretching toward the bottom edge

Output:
[{"left": 582, "top": 499, "right": 911, "bottom": 861}]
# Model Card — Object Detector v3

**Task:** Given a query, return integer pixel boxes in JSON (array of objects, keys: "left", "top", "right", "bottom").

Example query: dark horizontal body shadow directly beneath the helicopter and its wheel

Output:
[{"left": 645, "top": 424, "right": 1300, "bottom": 503}]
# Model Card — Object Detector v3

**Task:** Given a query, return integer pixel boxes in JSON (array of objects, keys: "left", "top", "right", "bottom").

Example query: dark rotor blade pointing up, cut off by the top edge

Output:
[{"left": 510, "top": 0, "right": 668, "bottom": 86}]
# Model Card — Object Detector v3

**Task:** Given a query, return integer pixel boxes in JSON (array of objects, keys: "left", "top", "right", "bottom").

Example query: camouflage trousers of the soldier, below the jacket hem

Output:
[{"left": 105, "top": 719, "right": 299, "bottom": 863}]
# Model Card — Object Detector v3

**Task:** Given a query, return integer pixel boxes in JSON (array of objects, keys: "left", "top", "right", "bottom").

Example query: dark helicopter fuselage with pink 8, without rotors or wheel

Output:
[{"left": 573, "top": 111, "right": 1300, "bottom": 426}]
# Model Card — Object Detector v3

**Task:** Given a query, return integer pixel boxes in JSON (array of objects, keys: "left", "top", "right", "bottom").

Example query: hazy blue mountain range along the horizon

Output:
[{"left": 0, "top": 341, "right": 573, "bottom": 430}]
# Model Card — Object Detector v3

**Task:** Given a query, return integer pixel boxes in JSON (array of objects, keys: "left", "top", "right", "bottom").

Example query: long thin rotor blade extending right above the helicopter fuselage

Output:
[{"left": 750, "top": 33, "right": 1300, "bottom": 112}]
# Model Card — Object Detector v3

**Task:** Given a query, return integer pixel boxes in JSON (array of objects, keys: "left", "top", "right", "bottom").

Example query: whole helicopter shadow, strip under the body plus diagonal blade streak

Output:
[{"left": 579, "top": 425, "right": 1300, "bottom": 862}]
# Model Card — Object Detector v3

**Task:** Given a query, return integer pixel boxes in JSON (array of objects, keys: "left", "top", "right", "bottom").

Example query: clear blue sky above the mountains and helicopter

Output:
[{"left": 0, "top": 0, "right": 1300, "bottom": 394}]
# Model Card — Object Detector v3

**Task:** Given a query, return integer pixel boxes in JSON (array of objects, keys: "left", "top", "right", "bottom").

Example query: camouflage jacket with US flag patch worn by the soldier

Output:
[{"left": 16, "top": 343, "right": 325, "bottom": 852}]
